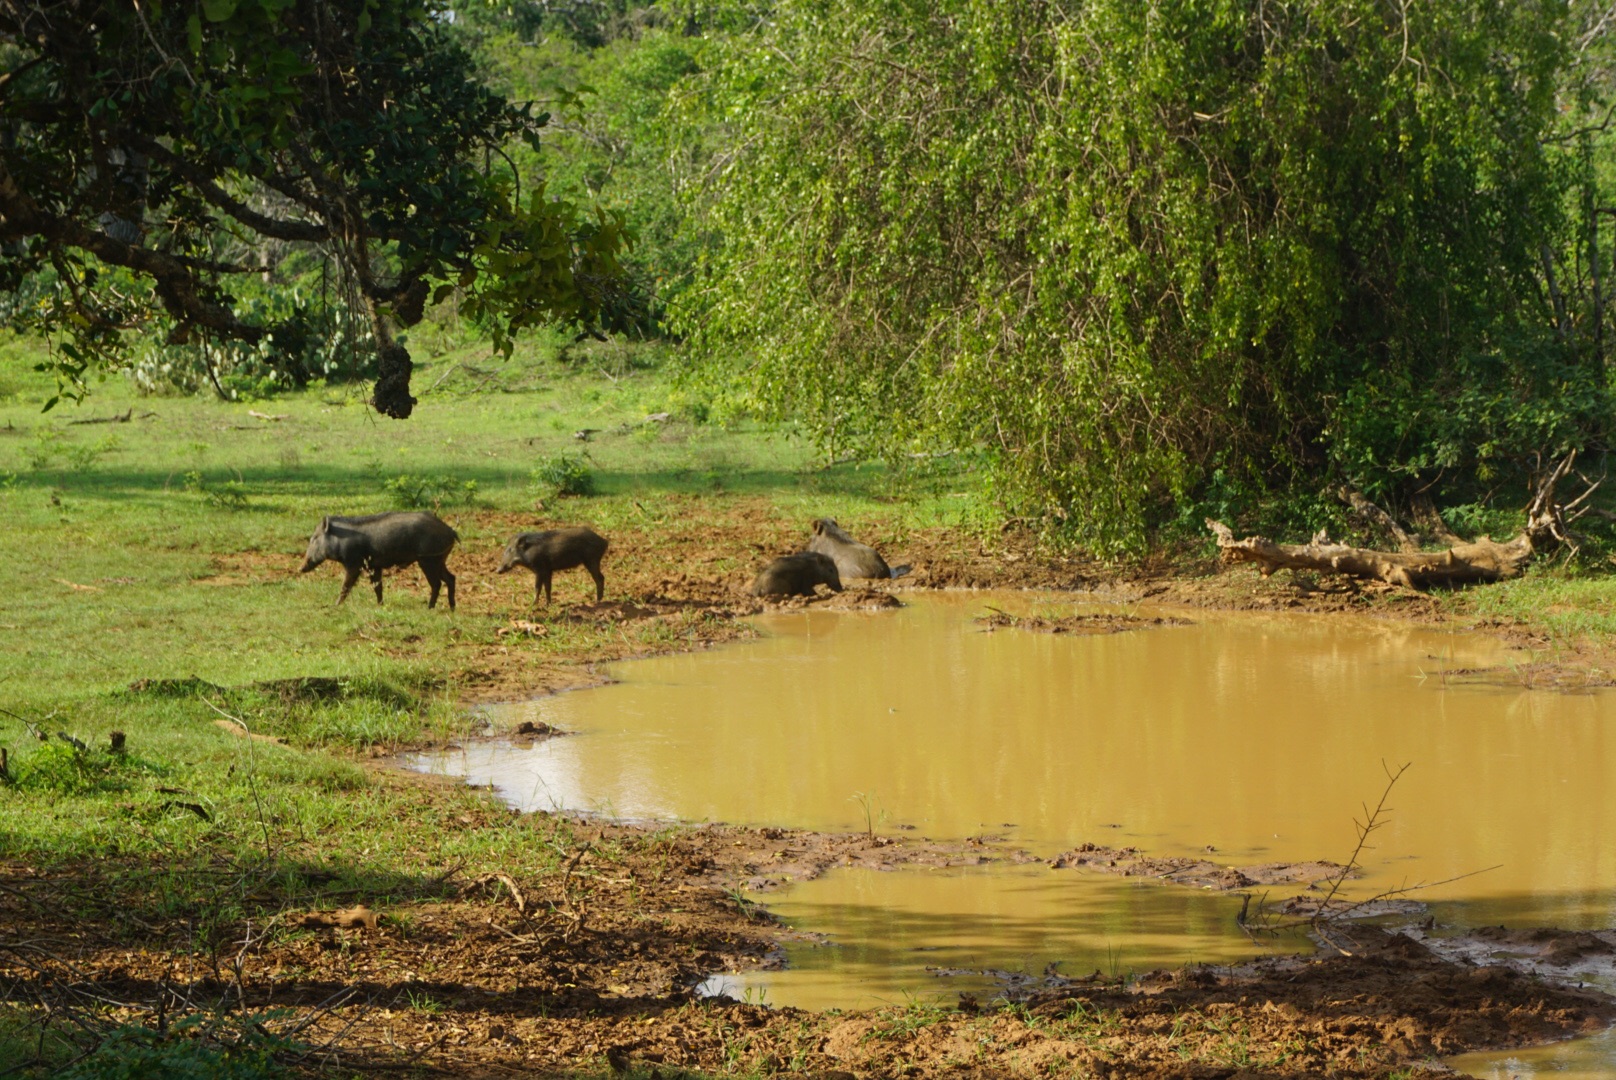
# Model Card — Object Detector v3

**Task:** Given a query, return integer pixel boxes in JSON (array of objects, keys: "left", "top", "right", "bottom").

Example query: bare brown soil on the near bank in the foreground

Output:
[{"left": 9, "top": 827, "right": 1616, "bottom": 1080}]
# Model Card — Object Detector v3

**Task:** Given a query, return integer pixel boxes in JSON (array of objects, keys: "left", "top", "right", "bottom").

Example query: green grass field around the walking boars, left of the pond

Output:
[{"left": 0, "top": 338, "right": 1616, "bottom": 1075}]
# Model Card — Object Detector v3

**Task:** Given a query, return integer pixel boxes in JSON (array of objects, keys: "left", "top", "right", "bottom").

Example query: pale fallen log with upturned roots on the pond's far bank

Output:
[{"left": 1206, "top": 453, "right": 1603, "bottom": 589}]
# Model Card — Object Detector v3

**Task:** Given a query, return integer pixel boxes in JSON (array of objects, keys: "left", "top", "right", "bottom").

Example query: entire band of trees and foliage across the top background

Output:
[{"left": 0, "top": 0, "right": 1616, "bottom": 550}]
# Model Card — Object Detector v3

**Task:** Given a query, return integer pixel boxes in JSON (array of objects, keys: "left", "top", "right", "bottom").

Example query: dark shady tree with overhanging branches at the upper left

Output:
[{"left": 0, "top": 0, "right": 624, "bottom": 417}]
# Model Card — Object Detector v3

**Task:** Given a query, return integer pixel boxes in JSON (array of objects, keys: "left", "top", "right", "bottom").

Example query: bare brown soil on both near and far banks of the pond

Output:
[{"left": 22, "top": 498, "right": 1616, "bottom": 1080}]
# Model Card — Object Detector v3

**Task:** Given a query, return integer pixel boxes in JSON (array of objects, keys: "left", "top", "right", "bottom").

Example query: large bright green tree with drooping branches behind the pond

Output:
[{"left": 685, "top": 0, "right": 1610, "bottom": 546}]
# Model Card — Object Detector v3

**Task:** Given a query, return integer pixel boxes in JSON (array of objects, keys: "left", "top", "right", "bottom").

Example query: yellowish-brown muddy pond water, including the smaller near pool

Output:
[{"left": 412, "top": 593, "right": 1616, "bottom": 1007}]
